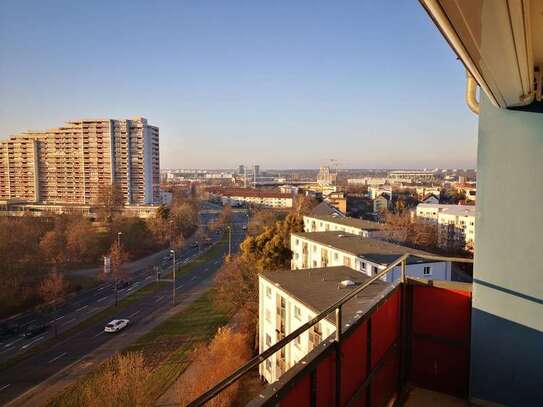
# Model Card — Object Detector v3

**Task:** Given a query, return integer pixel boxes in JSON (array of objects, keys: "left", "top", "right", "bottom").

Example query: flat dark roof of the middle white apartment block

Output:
[{"left": 292, "top": 231, "right": 442, "bottom": 266}]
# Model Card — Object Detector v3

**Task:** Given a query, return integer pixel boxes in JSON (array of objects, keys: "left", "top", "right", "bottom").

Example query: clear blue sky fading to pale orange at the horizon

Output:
[{"left": 0, "top": 0, "right": 476, "bottom": 168}]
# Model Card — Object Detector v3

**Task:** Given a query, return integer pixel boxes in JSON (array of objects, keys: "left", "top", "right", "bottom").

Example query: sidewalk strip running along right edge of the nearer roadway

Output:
[{"left": 6, "top": 278, "right": 213, "bottom": 407}]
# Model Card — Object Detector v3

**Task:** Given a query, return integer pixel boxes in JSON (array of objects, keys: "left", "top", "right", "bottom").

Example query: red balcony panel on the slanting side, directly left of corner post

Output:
[{"left": 371, "top": 290, "right": 400, "bottom": 368}]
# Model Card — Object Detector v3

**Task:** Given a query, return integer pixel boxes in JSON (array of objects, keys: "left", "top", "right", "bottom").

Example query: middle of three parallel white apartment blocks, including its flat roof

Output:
[{"left": 290, "top": 231, "right": 451, "bottom": 282}]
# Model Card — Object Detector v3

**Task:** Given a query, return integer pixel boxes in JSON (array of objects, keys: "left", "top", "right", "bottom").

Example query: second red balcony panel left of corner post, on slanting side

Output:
[{"left": 341, "top": 322, "right": 368, "bottom": 405}]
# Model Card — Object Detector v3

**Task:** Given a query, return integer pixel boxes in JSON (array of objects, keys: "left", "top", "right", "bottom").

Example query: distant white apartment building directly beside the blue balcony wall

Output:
[{"left": 417, "top": 204, "right": 475, "bottom": 251}]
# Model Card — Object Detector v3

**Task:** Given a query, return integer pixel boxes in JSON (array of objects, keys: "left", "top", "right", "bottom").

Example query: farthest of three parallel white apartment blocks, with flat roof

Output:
[{"left": 304, "top": 215, "right": 385, "bottom": 238}]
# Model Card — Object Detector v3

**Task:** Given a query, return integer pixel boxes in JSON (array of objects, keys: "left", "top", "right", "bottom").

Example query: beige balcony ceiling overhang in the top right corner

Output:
[{"left": 420, "top": 0, "right": 543, "bottom": 108}]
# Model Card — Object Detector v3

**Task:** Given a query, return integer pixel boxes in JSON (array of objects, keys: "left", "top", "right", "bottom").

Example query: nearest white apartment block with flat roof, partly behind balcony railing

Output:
[{"left": 258, "top": 266, "right": 394, "bottom": 383}]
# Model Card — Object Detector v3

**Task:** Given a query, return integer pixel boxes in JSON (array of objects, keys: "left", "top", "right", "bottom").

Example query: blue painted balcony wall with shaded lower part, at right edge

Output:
[{"left": 470, "top": 95, "right": 543, "bottom": 406}]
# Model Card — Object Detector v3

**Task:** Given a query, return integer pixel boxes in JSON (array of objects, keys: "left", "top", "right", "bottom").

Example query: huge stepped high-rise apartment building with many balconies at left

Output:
[{"left": 0, "top": 117, "right": 160, "bottom": 205}]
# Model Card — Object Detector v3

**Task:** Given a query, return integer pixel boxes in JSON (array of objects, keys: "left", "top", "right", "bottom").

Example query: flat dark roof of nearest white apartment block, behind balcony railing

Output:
[{"left": 260, "top": 266, "right": 395, "bottom": 329}]
